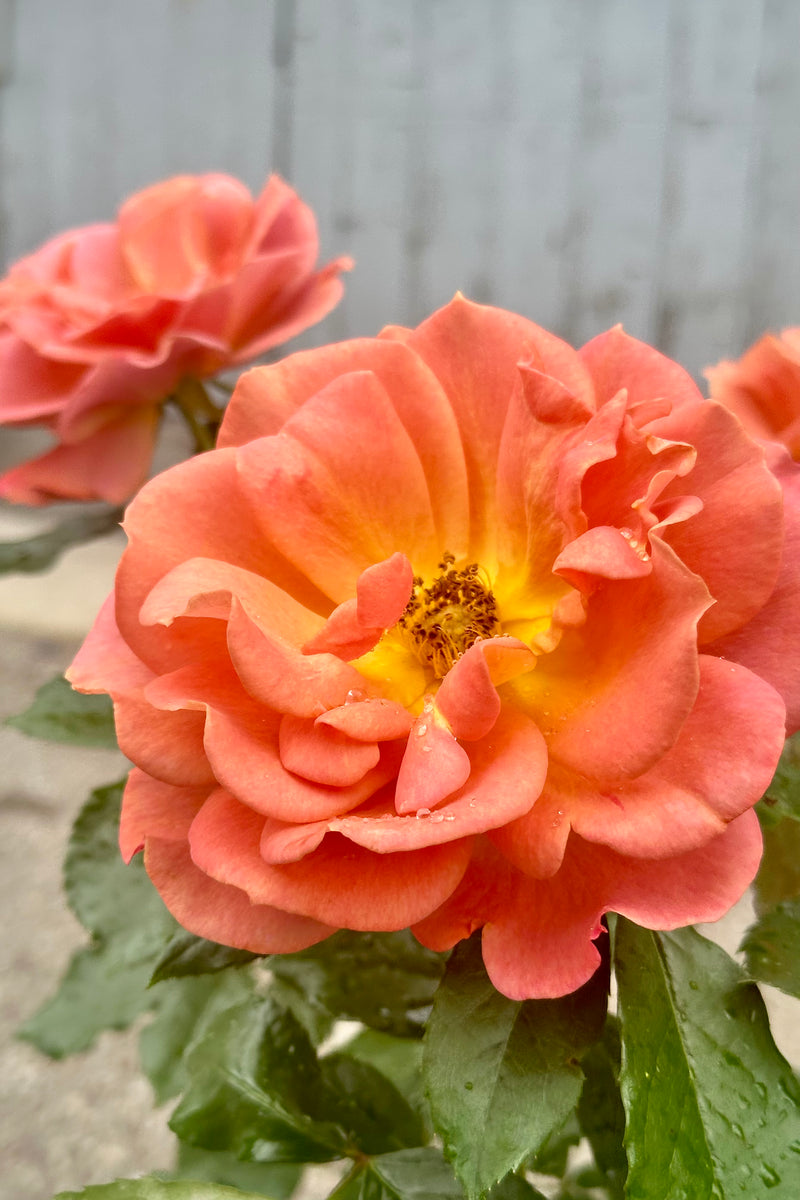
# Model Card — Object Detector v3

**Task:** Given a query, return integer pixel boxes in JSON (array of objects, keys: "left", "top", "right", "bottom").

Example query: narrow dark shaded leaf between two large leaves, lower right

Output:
[{"left": 578, "top": 1016, "right": 627, "bottom": 1200}]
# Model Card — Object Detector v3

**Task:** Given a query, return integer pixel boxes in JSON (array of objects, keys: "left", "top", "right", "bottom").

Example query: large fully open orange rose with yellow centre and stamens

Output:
[{"left": 71, "top": 298, "right": 800, "bottom": 998}]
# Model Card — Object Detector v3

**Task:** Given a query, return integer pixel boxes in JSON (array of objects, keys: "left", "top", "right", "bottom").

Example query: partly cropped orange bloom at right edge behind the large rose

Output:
[{"left": 705, "top": 329, "right": 800, "bottom": 461}]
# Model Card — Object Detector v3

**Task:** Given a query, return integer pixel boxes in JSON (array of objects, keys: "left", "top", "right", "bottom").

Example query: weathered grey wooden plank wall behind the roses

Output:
[{"left": 0, "top": 0, "right": 800, "bottom": 372}]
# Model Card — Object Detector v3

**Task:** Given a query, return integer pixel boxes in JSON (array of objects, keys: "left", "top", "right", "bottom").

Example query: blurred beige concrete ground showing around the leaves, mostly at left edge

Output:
[{"left": 0, "top": 496, "right": 800, "bottom": 1200}]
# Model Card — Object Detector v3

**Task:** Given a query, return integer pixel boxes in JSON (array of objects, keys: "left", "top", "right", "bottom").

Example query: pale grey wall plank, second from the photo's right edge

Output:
[{"left": 652, "top": 0, "right": 763, "bottom": 372}]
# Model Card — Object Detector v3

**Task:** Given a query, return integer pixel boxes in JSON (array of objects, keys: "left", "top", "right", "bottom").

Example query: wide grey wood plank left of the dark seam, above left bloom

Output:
[{"left": 2, "top": 0, "right": 273, "bottom": 257}]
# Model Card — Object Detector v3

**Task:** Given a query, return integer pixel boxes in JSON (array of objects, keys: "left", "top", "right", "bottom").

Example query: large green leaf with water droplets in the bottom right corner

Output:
[{"left": 615, "top": 919, "right": 800, "bottom": 1200}]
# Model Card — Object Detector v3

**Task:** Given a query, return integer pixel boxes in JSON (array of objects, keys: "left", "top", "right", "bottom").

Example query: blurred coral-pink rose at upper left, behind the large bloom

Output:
[{"left": 0, "top": 175, "right": 350, "bottom": 504}]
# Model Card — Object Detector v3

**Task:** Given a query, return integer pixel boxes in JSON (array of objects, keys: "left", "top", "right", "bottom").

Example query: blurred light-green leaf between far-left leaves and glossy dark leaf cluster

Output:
[{"left": 139, "top": 968, "right": 255, "bottom": 1099}]
